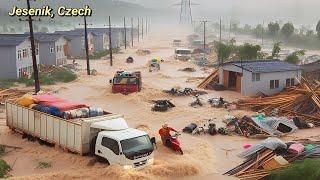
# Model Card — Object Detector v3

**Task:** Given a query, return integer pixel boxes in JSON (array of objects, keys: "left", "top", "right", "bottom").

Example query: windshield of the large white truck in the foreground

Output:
[{"left": 120, "top": 135, "right": 153, "bottom": 157}]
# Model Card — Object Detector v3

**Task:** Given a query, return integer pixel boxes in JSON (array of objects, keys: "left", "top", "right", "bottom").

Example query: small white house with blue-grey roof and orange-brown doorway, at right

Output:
[{"left": 219, "top": 60, "right": 302, "bottom": 96}]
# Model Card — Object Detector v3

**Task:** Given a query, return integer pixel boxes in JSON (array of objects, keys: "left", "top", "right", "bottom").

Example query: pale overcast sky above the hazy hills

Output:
[{"left": 126, "top": 0, "right": 320, "bottom": 24}]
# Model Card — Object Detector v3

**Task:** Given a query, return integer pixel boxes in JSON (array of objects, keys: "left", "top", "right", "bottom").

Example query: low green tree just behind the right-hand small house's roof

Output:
[{"left": 237, "top": 43, "right": 261, "bottom": 60}]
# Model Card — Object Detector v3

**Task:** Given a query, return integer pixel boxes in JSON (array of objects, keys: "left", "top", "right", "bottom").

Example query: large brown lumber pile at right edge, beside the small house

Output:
[{"left": 237, "top": 78, "right": 320, "bottom": 126}]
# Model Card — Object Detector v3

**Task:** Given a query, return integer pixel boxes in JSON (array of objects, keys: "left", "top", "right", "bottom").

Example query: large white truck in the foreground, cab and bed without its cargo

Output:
[{"left": 6, "top": 101, "right": 155, "bottom": 169}]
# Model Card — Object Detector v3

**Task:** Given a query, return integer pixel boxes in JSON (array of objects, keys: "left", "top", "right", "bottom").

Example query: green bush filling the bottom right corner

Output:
[{"left": 268, "top": 158, "right": 320, "bottom": 180}]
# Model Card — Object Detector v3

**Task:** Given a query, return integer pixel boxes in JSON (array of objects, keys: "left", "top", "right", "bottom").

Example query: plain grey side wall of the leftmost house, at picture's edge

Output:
[{"left": 0, "top": 46, "right": 17, "bottom": 79}]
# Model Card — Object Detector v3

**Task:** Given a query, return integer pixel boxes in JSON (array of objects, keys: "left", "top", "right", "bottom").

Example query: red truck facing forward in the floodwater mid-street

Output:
[{"left": 110, "top": 71, "right": 141, "bottom": 94}]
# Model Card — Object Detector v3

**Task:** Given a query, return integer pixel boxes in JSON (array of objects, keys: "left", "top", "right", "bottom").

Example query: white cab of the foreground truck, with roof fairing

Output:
[{"left": 91, "top": 118, "right": 155, "bottom": 169}]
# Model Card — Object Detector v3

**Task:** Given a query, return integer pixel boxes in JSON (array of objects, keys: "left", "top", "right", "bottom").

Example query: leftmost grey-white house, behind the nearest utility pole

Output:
[{"left": 0, "top": 34, "right": 39, "bottom": 79}]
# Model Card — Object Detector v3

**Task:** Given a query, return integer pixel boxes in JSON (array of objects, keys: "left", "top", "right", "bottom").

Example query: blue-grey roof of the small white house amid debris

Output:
[{"left": 224, "top": 60, "right": 301, "bottom": 73}]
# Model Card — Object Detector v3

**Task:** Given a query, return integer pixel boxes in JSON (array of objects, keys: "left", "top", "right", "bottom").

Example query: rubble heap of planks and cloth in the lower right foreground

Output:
[{"left": 224, "top": 138, "right": 320, "bottom": 179}]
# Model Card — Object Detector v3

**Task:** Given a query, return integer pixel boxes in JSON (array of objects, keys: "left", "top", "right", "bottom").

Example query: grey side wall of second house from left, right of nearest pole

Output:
[{"left": 39, "top": 42, "right": 56, "bottom": 65}]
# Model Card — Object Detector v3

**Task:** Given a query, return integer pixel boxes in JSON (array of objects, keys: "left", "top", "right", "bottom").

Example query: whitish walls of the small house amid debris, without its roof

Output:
[{"left": 219, "top": 65, "right": 301, "bottom": 96}]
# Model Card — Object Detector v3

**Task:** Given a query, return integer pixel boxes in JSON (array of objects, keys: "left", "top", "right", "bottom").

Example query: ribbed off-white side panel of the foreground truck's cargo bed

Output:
[{"left": 6, "top": 102, "right": 83, "bottom": 154}]
